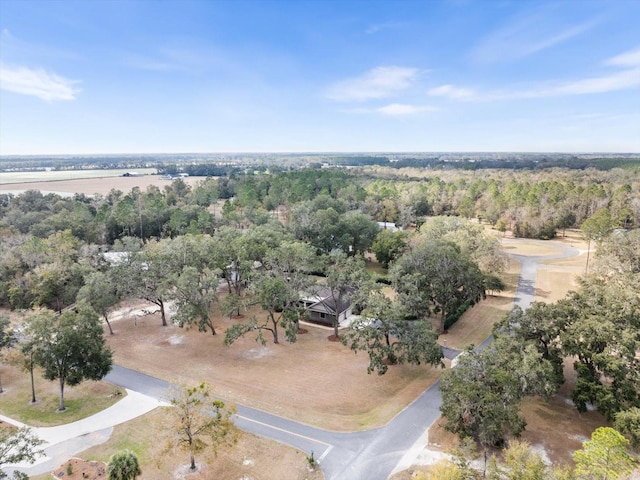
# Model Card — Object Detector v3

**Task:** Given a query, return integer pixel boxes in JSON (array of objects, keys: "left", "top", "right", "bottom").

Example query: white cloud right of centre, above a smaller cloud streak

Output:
[{"left": 327, "top": 66, "right": 418, "bottom": 102}]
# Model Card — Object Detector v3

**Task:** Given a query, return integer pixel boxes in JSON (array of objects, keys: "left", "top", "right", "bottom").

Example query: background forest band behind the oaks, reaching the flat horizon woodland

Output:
[{"left": 0, "top": 167, "right": 640, "bottom": 307}]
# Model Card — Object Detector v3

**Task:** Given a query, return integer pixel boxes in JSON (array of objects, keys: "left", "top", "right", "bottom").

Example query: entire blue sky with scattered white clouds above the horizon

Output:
[{"left": 0, "top": 0, "right": 640, "bottom": 155}]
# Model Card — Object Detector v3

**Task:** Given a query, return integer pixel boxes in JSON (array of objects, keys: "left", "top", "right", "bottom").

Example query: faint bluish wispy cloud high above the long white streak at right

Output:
[{"left": 471, "top": 12, "right": 597, "bottom": 63}]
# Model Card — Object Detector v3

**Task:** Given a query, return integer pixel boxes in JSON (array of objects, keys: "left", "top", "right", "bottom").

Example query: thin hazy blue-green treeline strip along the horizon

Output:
[{"left": 0, "top": 153, "right": 640, "bottom": 173}]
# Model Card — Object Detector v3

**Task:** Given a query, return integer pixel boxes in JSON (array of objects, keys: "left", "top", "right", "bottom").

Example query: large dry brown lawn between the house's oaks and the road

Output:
[{"left": 108, "top": 300, "right": 439, "bottom": 430}]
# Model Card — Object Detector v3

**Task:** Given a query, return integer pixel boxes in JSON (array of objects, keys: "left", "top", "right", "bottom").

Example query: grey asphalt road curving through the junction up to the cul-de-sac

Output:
[{"left": 2, "top": 240, "right": 579, "bottom": 480}]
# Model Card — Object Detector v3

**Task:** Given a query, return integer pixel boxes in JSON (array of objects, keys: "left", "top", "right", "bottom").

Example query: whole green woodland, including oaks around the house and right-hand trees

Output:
[{"left": 0, "top": 165, "right": 640, "bottom": 464}]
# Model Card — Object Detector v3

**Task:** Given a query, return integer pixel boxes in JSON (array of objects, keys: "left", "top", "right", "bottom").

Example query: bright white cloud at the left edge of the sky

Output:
[{"left": 0, "top": 64, "right": 80, "bottom": 102}]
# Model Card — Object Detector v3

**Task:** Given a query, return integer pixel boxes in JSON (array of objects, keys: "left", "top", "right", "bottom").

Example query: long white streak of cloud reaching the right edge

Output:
[{"left": 427, "top": 48, "right": 640, "bottom": 101}]
